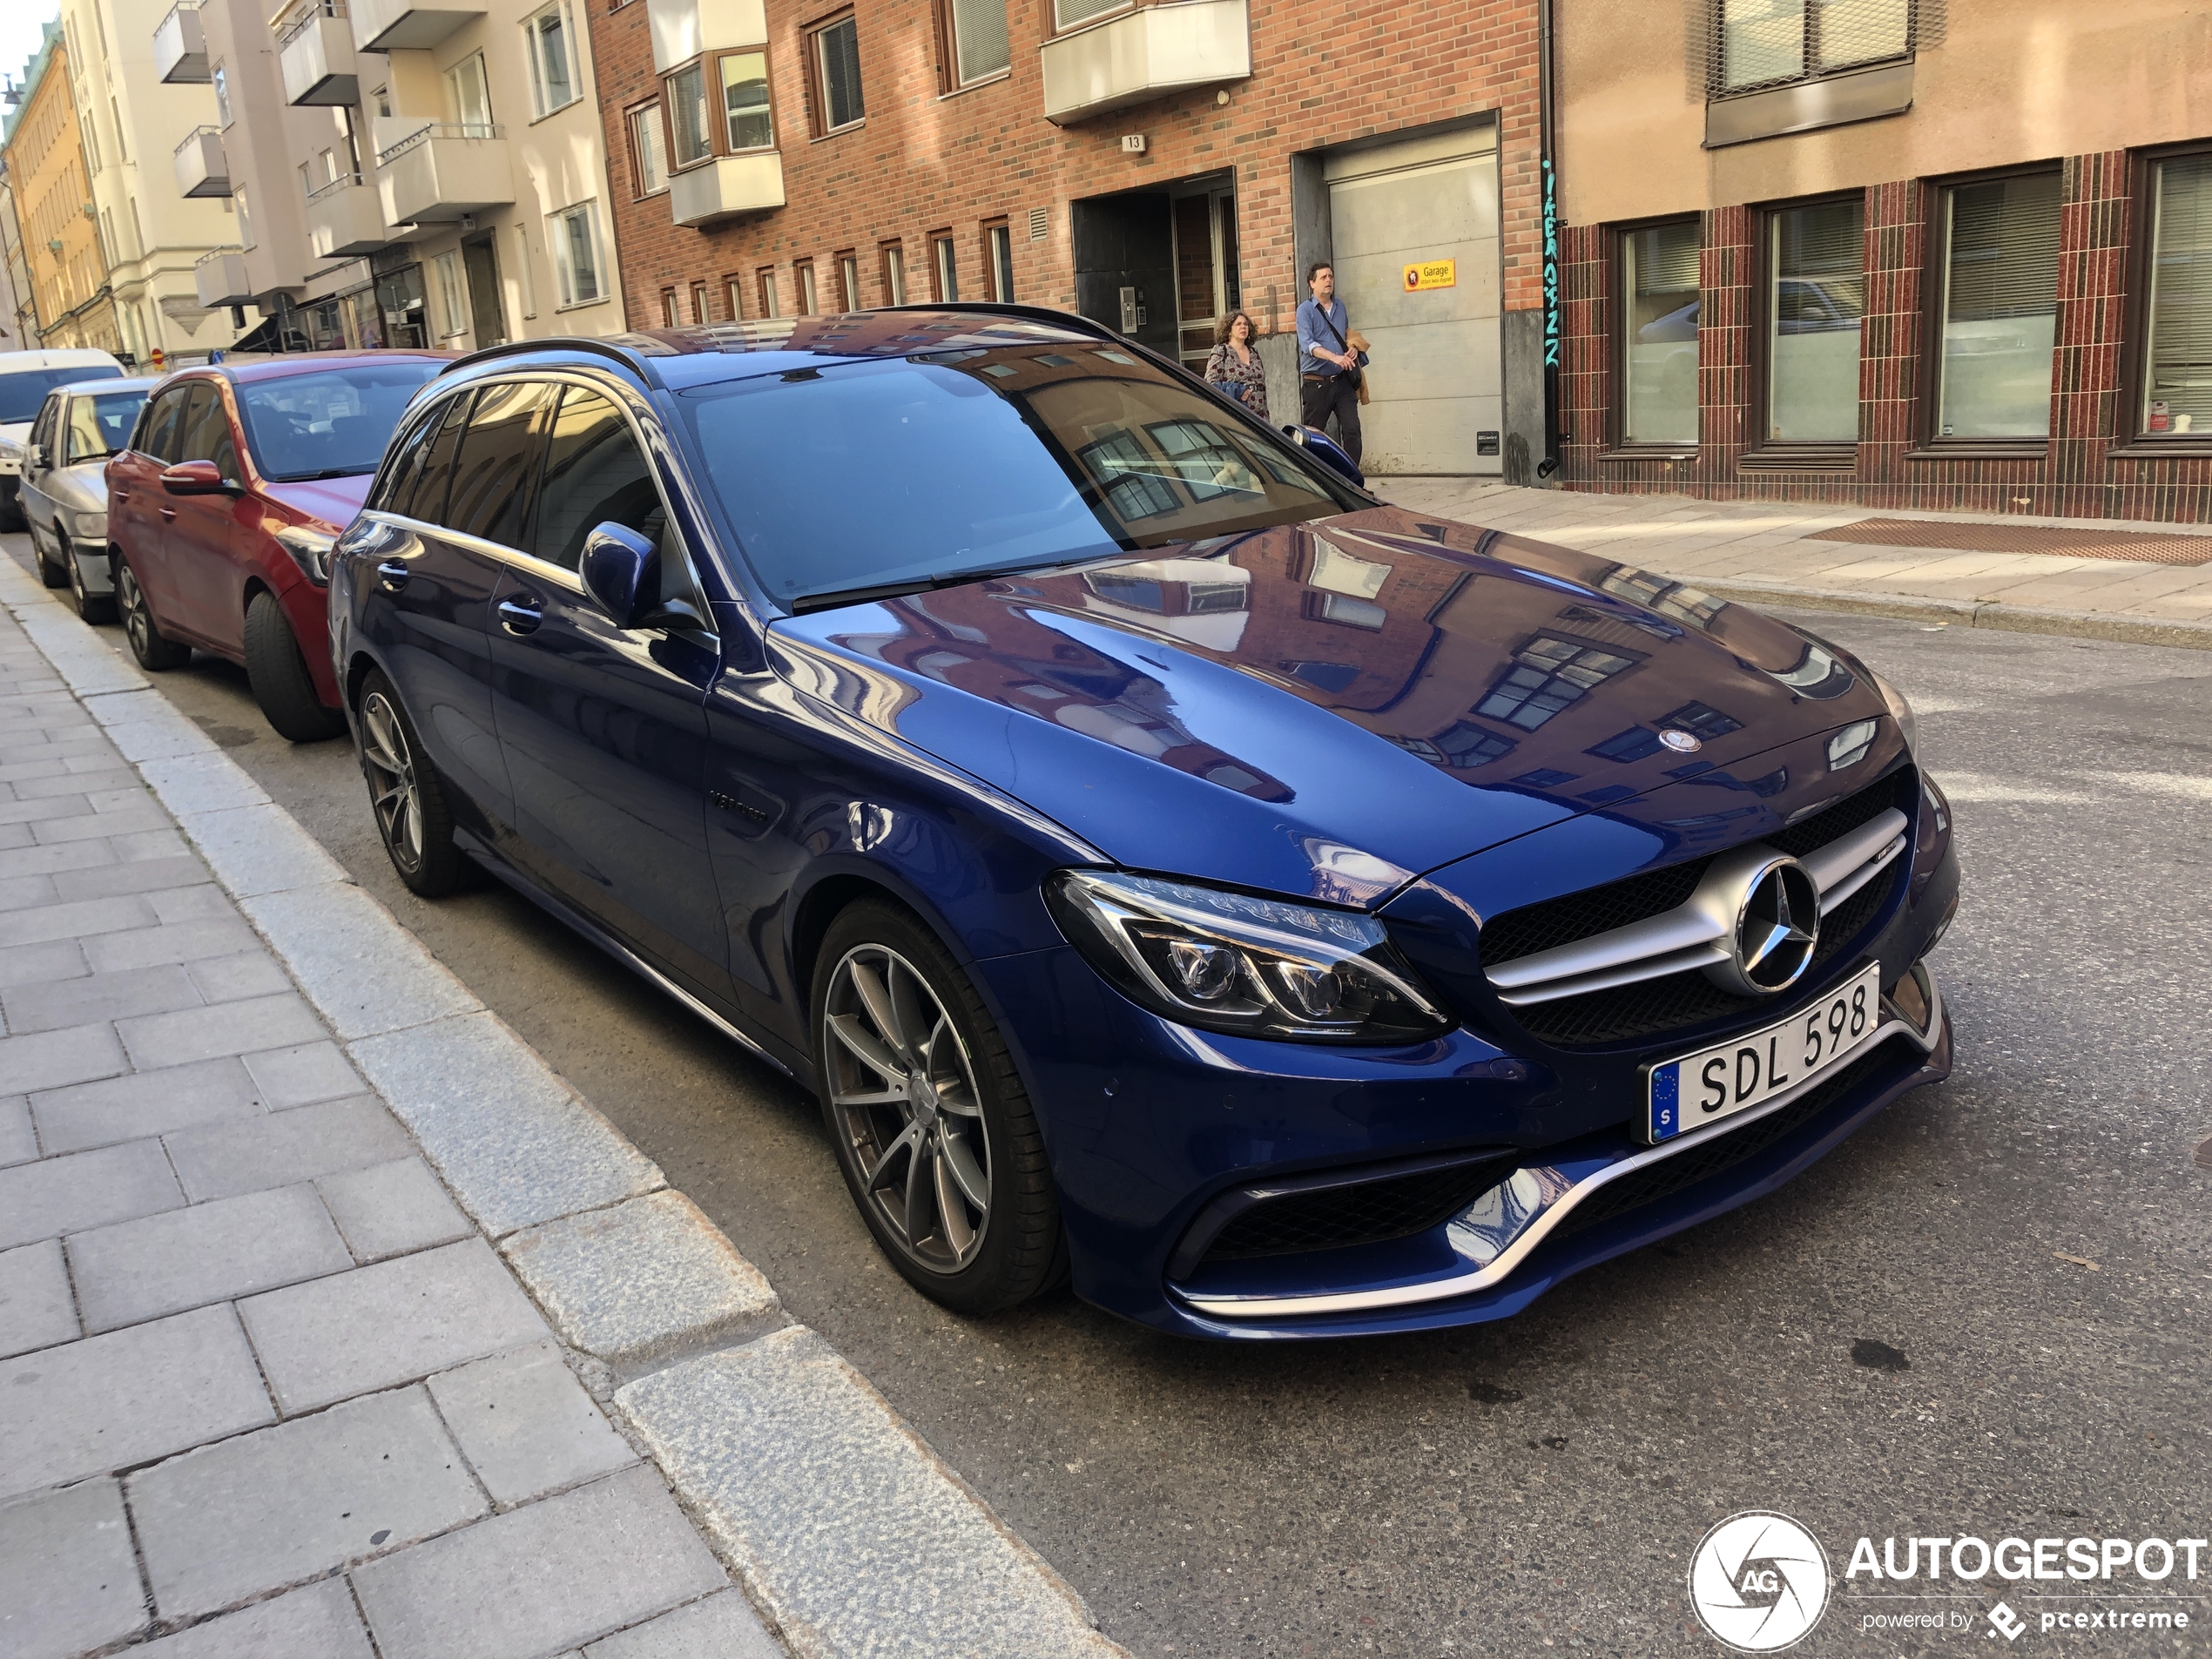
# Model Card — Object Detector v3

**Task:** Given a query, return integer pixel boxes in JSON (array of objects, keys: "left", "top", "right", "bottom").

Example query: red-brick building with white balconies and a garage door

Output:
[{"left": 589, "top": 0, "right": 1544, "bottom": 474}]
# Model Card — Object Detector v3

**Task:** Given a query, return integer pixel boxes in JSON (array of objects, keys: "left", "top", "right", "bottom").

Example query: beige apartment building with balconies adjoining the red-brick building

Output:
[{"left": 155, "top": 0, "right": 624, "bottom": 349}]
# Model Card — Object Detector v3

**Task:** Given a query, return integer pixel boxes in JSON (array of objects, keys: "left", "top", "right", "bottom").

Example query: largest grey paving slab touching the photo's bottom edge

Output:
[{"left": 354, "top": 1467, "right": 728, "bottom": 1659}]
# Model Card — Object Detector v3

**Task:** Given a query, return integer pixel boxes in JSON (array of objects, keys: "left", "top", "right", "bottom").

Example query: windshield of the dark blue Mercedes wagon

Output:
[{"left": 677, "top": 341, "right": 1363, "bottom": 610}]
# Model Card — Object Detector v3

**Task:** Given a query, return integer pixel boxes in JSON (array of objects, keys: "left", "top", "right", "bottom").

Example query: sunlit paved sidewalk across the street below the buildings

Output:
[{"left": 1373, "top": 478, "right": 2212, "bottom": 648}]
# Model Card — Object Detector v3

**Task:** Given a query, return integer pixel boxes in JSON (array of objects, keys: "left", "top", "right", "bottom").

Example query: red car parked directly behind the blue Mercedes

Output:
[{"left": 106, "top": 352, "right": 451, "bottom": 743}]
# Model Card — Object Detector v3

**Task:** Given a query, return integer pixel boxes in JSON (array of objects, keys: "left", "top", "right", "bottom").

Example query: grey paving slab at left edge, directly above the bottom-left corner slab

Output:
[{"left": 0, "top": 1307, "right": 277, "bottom": 1498}]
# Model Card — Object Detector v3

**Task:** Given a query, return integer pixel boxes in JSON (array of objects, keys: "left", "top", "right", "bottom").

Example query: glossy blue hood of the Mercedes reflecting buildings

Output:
[{"left": 770, "top": 507, "right": 1885, "bottom": 905}]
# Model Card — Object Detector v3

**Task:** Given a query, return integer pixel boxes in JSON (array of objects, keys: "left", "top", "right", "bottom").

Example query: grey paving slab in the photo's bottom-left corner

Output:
[{"left": 0, "top": 1480, "right": 146, "bottom": 1659}]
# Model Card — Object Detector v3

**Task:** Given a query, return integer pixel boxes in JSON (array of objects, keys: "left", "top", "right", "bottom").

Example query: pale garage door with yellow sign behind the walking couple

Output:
[{"left": 1325, "top": 128, "right": 1504, "bottom": 474}]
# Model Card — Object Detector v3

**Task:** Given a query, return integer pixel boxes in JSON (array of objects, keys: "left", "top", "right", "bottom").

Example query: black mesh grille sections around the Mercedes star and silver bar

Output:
[{"left": 1482, "top": 767, "right": 1916, "bottom": 1049}]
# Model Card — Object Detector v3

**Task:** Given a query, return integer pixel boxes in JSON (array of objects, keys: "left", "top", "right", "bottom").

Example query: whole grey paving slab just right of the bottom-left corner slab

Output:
[{"left": 126, "top": 1387, "right": 491, "bottom": 1628}]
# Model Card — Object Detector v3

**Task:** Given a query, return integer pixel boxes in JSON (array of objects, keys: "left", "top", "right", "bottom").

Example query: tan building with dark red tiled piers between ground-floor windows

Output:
[{"left": 1555, "top": 0, "right": 2212, "bottom": 520}]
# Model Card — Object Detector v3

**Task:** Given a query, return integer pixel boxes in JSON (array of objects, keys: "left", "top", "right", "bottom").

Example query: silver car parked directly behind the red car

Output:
[{"left": 22, "top": 381, "right": 159, "bottom": 622}]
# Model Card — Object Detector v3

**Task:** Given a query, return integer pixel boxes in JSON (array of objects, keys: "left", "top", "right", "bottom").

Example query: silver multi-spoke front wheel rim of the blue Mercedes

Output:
[{"left": 823, "top": 945, "right": 991, "bottom": 1274}]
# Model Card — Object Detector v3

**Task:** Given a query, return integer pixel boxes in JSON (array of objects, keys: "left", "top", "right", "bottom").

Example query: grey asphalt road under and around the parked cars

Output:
[{"left": 21, "top": 536, "right": 2212, "bottom": 1656}]
